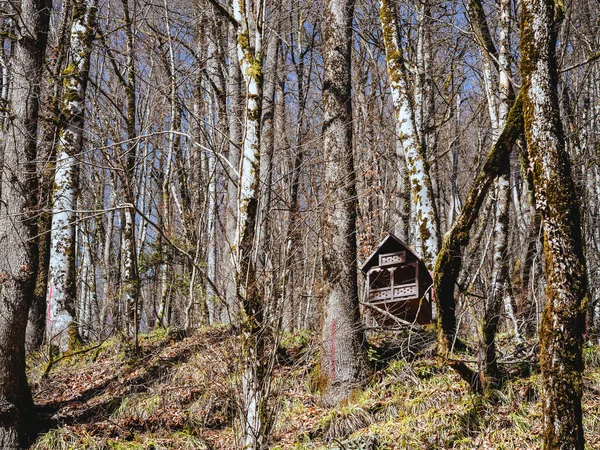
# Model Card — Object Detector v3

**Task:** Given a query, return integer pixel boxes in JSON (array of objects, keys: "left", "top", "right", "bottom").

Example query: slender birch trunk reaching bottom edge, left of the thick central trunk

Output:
[{"left": 233, "top": 0, "right": 271, "bottom": 449}]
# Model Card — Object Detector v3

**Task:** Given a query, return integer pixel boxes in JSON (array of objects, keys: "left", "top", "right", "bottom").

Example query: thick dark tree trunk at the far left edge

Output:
[{"left": 0, "top": 0, "right": 51, "bottom": 444}]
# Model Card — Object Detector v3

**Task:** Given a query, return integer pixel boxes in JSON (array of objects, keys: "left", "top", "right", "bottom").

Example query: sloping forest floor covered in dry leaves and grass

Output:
[{"left": 28, "top": 326, "right": 600, "bottom": 450}]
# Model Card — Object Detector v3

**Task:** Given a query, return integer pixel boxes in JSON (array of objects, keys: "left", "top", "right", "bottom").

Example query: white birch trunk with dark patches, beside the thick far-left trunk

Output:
[{"left": 46, "top": 0, "right": 97, "bottom": 352}]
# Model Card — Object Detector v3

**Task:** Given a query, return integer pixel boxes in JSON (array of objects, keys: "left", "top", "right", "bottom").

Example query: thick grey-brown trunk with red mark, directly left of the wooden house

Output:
[{"left": 320, "top": 0, "right": 368, "bottom": 405}]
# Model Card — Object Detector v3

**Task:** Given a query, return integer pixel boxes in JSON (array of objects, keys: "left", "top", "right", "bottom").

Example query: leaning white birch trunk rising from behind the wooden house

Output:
[{"left": 379, "top": 0, "right": 439, "bottom": 270}]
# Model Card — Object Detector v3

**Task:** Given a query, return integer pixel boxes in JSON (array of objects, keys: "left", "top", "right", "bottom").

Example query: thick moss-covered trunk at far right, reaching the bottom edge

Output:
[{"left": 521, "top": 0, "right": 587, "bottom": 450}]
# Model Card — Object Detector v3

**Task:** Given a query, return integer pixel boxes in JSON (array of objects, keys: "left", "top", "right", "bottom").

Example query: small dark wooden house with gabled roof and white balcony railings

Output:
[{"left": 360, "top": 233, "right": 433, "bottom": 326}]
